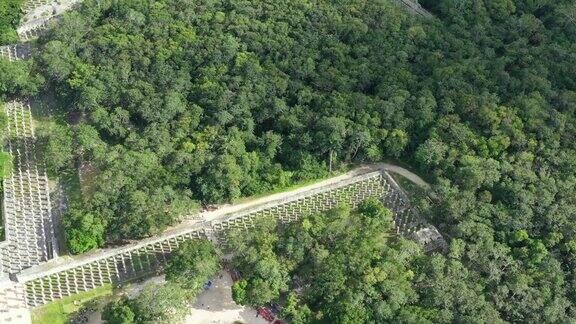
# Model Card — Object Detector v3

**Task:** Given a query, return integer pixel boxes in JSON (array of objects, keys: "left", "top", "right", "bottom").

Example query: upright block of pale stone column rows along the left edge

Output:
[{"left": 0, "top": 102, "right": 55, "bottom": 273}]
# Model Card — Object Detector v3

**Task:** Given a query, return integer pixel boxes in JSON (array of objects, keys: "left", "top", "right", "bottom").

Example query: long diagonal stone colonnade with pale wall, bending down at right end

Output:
[{"left": 16, "top": 170, "right": 446, "bottom": 307}]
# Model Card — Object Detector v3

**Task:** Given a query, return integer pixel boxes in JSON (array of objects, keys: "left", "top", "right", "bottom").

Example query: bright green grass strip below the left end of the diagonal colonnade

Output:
[{"left": 32, "top": 284, "right": 113, "bottom": 324}]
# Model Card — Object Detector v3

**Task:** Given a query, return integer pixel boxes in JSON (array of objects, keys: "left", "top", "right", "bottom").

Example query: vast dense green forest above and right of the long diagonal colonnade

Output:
[{"left": 0, "top": 0, "right": 576, "bottom": 322}]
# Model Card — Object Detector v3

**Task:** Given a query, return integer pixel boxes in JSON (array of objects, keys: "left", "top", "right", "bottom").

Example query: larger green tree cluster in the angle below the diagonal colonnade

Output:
[{"left": 229, "top": 200, "right": 426, "bottom": 324}]
